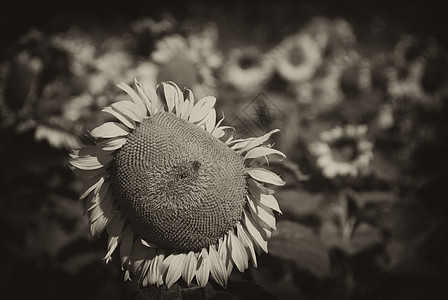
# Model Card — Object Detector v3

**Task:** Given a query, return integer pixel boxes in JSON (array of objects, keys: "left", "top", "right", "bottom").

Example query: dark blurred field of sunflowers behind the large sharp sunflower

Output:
[{"left": 0, "top": 0, "right": 448, "bottom": 300}]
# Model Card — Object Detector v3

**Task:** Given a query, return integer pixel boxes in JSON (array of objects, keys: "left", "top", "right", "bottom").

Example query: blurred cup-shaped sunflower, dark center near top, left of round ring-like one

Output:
[{"left": 223, "top": 47, "right": 274, "bottom": 94}]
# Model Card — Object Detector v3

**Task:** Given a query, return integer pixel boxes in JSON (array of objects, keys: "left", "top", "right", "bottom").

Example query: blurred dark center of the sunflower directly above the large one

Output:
[{"left": 157, "top": 55, "right": 199, "bottom": 89}]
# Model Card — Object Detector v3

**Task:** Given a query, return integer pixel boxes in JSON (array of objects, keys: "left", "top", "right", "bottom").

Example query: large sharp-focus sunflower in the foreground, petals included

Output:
[{"left": 70, "top": 80, "right": 285, "bottom": 288}]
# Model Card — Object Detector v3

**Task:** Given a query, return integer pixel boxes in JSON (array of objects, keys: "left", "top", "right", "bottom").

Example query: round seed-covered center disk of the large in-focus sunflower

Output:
[{"left": 111, "top": 113, "right": 246, "bottom": 252}]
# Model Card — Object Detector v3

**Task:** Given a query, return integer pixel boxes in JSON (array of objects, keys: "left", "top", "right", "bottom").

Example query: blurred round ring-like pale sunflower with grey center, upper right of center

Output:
[{"left": 274, "top": 34, "right": 322, "bottom": 83}]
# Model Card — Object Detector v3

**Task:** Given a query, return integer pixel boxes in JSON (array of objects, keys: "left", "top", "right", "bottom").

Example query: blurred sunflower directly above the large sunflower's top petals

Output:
[{"left": 151, "top": 27, "right": 221, "bottom": 97}]
